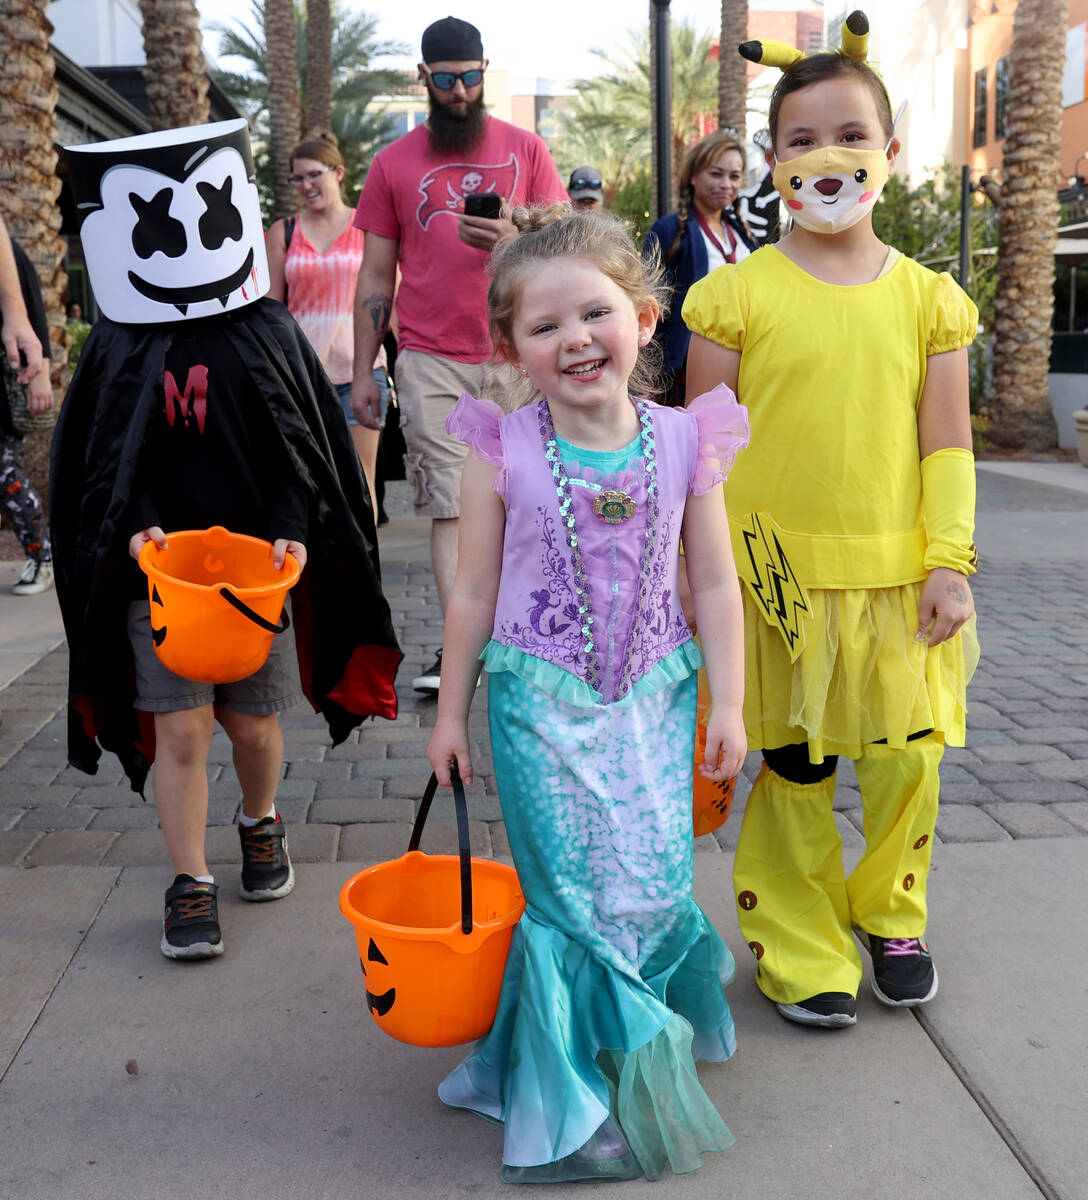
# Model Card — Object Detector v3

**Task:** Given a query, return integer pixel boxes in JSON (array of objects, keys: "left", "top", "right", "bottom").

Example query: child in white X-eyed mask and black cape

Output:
[{"left": 50, "top": 120, "right": 401, "bottom": 959}]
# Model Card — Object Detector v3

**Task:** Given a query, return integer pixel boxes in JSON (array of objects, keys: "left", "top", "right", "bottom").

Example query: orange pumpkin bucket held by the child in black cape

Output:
[{"left": 138, "top": 526, "right": 301, "bottom": 683}]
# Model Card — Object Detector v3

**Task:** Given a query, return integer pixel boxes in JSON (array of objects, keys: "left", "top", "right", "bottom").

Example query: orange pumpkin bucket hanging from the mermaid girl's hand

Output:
[{"left": 339, "top": 769, "right": 525, "bottom": 1046}]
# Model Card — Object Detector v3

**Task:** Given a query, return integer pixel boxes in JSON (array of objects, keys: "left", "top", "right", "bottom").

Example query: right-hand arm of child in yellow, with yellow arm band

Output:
[{"left": 915, "top": 349, "right": 974, "bottom": 646}]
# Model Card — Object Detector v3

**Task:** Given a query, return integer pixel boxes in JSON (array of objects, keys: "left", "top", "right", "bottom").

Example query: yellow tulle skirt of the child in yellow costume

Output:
[{"left": 744, "top": 583, "right": 979, "bottom": 762}]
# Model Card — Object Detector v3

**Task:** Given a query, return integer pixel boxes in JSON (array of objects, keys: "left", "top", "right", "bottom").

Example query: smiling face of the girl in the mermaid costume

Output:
[{"left": 505, "top": 258, "right": 657, "bottom": 415}]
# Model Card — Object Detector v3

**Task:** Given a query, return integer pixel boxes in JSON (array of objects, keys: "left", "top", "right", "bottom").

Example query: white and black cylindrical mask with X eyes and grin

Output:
[{"left": 65, "top": 119, "right": 269, "bottom": 324}]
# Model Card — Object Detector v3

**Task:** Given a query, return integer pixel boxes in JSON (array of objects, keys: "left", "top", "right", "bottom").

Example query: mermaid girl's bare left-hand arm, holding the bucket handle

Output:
[{"left": 427, "top": 457, "right": 506, "bottom": 787}]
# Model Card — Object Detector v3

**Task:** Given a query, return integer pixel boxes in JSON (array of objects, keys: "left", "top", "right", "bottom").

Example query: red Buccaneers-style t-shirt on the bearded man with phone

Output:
[{"left": 354, "top": 116, "right": 567, "bottom": 362}]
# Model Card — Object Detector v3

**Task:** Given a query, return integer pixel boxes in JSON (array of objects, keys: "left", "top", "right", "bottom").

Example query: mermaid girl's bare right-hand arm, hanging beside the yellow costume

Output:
[{"left": 683, "top": 487, "right": 747, "bottom": 780}]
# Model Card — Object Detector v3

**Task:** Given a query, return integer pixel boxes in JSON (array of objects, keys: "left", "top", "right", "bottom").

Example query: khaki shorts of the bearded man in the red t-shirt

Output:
[{"left": 396, "top": 350, "right": 518, "bottom": 521}]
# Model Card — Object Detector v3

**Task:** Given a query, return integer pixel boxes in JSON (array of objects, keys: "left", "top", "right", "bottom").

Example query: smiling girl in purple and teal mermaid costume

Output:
[{"left": 428, "top": 205, "right": 747, "bottom": 1182}]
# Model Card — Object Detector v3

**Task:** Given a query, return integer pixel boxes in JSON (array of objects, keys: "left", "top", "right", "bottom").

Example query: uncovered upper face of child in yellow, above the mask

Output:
[{"left": 768, "top": 76, "right": 898, "bottom": 166}]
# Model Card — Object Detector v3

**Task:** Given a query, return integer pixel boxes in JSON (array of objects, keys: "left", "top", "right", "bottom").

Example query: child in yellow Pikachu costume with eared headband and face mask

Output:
[{"left": 684, "top": 12, "right": 978, "bottom": 1028}]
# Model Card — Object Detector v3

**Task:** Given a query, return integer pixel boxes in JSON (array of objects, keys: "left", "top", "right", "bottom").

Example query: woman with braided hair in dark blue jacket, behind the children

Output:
[{"left": 642, "top": 130, "right": 757, "bottom": 404}]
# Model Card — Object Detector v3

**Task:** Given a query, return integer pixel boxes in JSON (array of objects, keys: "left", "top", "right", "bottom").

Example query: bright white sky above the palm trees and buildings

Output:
[{"left": 197, "top": 0, "right": 738, "bottom": 87}]
